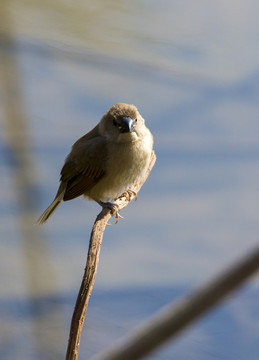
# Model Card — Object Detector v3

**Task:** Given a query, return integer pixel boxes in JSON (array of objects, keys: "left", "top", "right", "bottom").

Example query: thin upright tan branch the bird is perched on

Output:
[{"left": 66, "top": 151, "right": 156, "bottom": 360}]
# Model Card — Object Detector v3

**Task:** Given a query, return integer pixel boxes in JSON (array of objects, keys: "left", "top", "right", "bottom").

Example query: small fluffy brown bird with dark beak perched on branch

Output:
[{"left": 37, "top": 103, "right": 153, "bottom": 224}]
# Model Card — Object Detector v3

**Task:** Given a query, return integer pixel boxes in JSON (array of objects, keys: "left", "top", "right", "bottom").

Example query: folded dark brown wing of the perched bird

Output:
[{"left": 60, "top": 136, "right": 108, "bottom": 201}]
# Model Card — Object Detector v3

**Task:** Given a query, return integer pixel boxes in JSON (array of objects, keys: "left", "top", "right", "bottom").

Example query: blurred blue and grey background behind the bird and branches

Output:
[{"left": 0, "top": 0, "right": 259, "bottom": 360}]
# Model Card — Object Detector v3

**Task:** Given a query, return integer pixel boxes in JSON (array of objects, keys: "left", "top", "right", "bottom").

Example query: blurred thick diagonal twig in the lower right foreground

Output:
[{"left": 92, "top": 247, "right": 259, "bottom": 360}]
